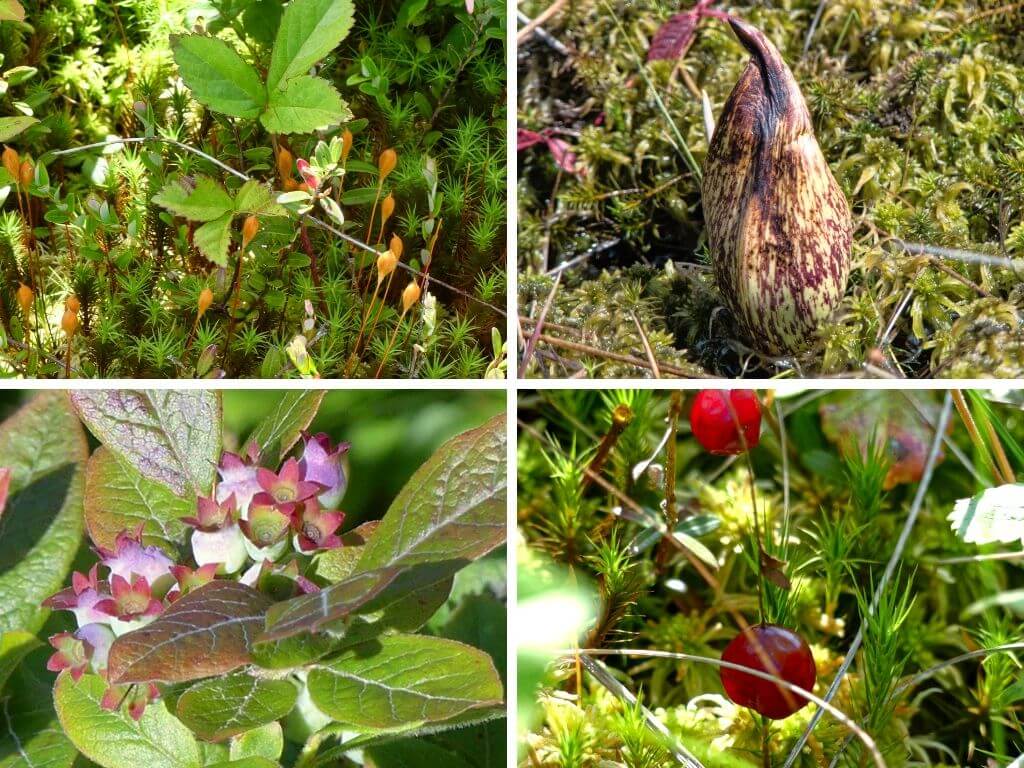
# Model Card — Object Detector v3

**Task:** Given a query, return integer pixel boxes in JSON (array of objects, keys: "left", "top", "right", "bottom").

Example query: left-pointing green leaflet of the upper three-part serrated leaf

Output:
[{"left": 171, "top": 35, "right": 266, "bottom": 118}]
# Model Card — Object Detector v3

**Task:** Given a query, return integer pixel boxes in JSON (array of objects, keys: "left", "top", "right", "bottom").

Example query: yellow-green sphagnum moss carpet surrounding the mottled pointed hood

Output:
[{"left": 518, "top": 0, "right": 1024, "bottom": 377}]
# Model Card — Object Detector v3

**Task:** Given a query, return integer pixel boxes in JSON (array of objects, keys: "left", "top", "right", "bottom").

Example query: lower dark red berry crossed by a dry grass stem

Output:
[{"left": 720, "top": 624, "right": 818, "bottom": 720}]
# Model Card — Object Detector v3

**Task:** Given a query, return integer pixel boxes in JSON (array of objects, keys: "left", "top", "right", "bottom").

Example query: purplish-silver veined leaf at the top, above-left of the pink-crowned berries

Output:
[{"left": 71, "top": 389, "right": 221, "bottom": 501}]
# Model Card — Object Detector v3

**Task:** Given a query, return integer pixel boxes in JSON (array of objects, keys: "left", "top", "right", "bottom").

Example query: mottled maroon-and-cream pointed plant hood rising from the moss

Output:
[{"left": 701, "top": 18, "right": 852, "bottom": 354}]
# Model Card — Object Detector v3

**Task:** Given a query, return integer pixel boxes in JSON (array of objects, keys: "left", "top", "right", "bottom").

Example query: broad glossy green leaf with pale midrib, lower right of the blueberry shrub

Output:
[{"left": 308, "top": 635, "right": 503, "bottom": 731}]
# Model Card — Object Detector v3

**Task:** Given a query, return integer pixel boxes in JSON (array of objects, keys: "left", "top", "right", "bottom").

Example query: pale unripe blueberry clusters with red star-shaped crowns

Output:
[{"left": 44, "top": 433, "right": 348, "bottom": 720}]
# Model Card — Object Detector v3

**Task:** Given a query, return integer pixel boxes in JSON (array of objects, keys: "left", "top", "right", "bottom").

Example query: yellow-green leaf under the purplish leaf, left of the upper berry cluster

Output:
[{"left": 85, "top": 445, "right": 196, "bottom": 554}]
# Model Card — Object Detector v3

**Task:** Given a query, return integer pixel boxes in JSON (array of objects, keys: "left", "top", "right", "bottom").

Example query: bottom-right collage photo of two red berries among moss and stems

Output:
[{"left": 517, "top": 390, "right": 1024, "bottom": 768}]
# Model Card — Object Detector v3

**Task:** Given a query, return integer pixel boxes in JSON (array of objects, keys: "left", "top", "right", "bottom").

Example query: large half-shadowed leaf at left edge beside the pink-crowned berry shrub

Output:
[{"left": 0, "top": 391, "right": 88, "bottom": 633}]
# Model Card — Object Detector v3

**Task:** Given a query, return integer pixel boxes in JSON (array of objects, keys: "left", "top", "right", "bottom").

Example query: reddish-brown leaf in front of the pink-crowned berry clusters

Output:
[{"left": 108, "top": 581, "right": 271, "bottom": 683}]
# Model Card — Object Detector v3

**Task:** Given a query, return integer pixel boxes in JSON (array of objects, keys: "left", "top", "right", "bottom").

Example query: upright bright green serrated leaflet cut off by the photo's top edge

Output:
[{"left": 266, "top": 0, "right": 354, "bottom": 91}]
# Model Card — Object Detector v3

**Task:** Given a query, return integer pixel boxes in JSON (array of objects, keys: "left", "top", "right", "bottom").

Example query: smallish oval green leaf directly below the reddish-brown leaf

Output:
[{"left": 177, "top": 674, "right": 299, "bottom": 741}]
